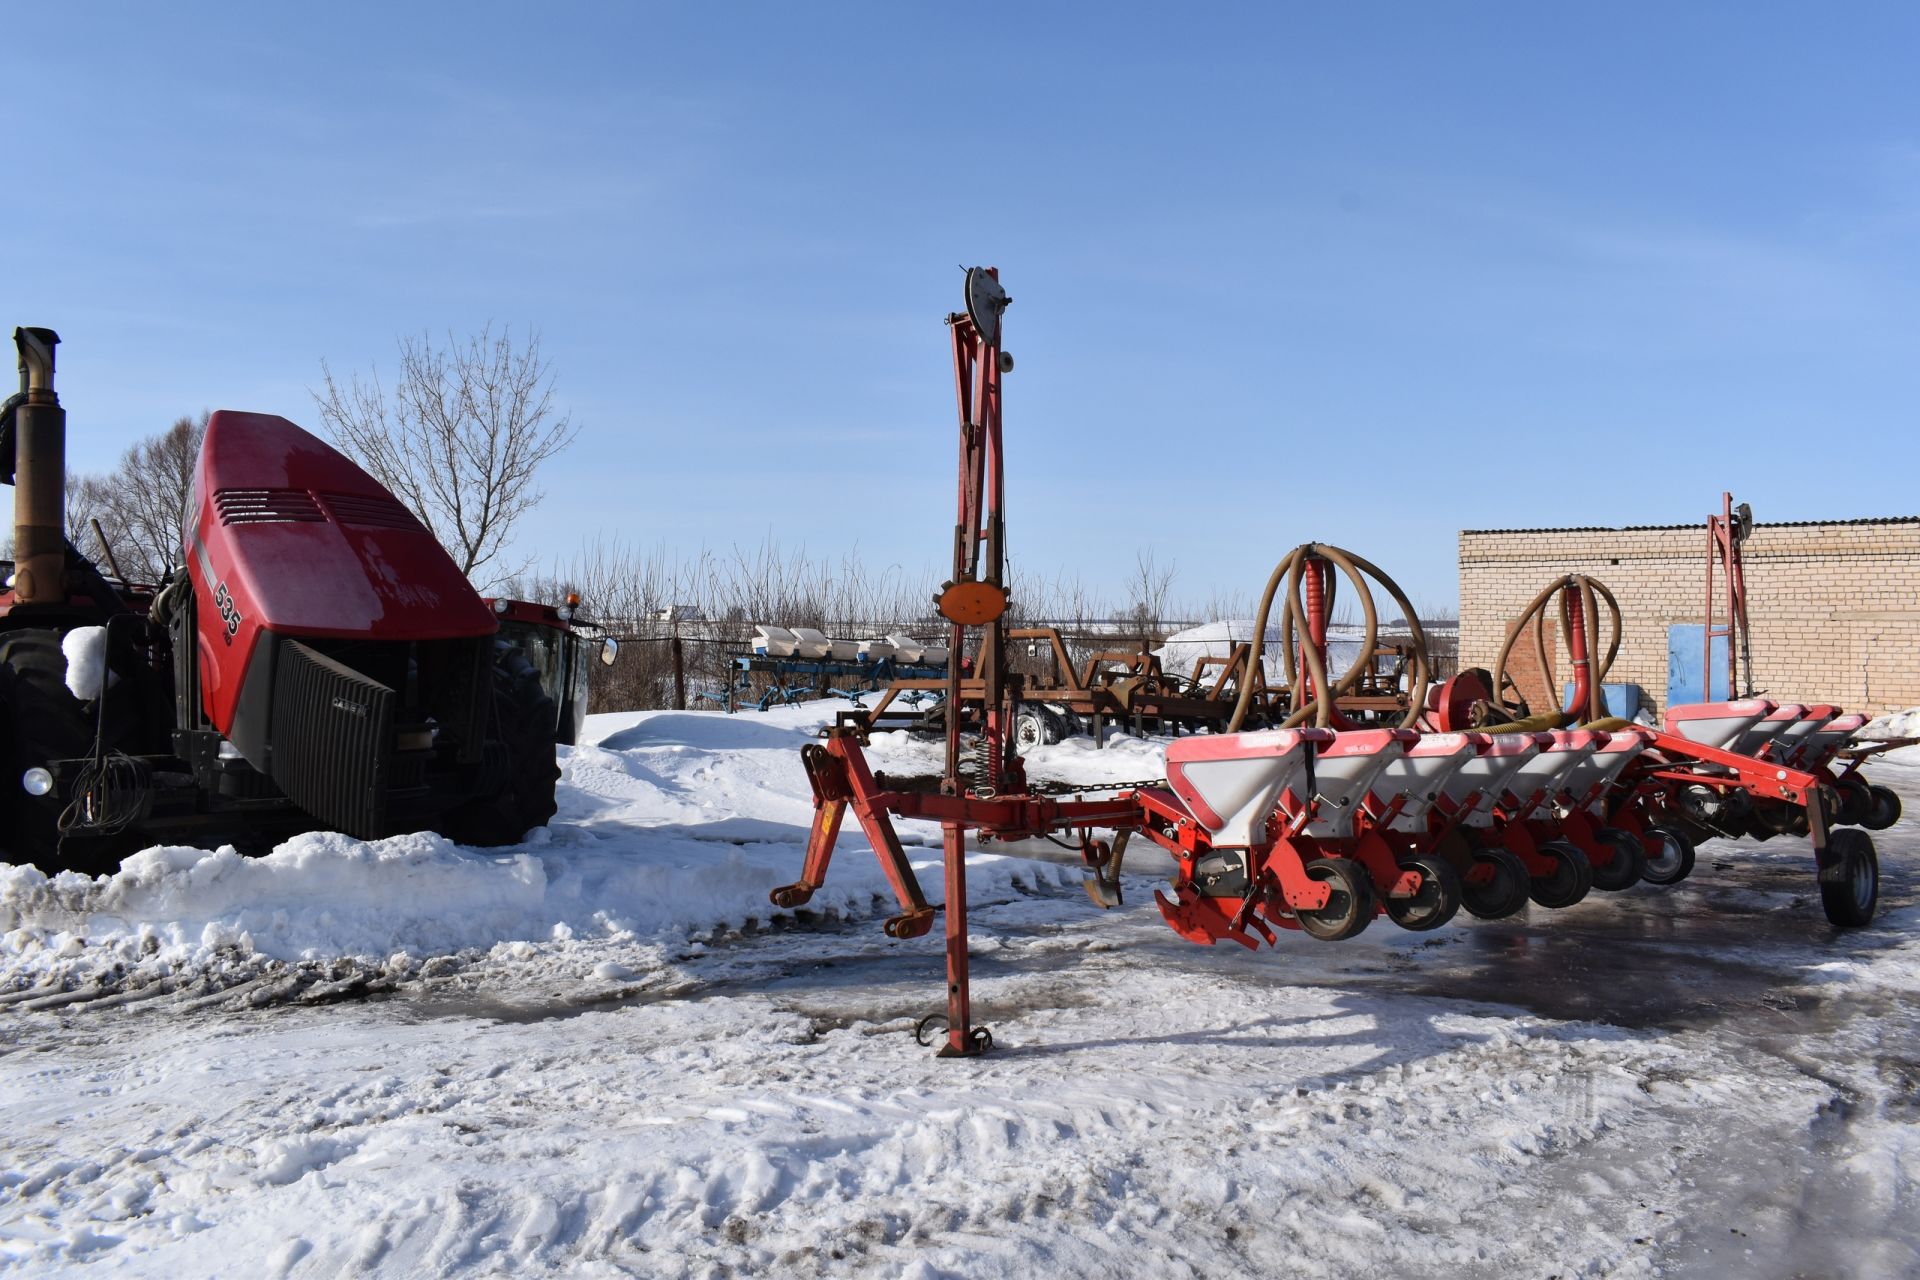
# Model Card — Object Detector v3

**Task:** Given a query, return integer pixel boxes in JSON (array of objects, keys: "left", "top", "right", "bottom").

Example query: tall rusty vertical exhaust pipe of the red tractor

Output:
[{"left": 13, "top": 328, "right": 67, "bottom": 604}]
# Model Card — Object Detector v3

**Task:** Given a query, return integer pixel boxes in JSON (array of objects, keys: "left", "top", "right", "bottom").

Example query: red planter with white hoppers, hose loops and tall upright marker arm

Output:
[{"left": 772, "top": 269, "right": 1899, "bottom": 1055}]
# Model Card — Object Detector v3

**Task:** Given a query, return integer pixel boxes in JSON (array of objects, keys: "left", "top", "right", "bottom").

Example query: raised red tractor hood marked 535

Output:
[{"left": 186, "top": 409, "right": 495, "bottom": 652}]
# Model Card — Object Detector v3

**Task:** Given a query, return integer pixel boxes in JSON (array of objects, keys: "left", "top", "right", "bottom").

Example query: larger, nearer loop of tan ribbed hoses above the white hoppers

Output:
[{"left": 1227, "top": 543, "right": 1432, "bottom": 733}]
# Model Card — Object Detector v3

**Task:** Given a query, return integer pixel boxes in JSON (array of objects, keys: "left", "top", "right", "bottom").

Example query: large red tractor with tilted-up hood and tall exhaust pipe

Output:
[{"left": 0, "top": 328, "right": 559, "bottom": 871}]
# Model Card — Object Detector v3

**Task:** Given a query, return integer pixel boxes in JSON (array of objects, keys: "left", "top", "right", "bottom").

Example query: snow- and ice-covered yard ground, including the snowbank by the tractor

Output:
[{"left": 0, "top": 708, "right": 1920, "bottom": 1280}]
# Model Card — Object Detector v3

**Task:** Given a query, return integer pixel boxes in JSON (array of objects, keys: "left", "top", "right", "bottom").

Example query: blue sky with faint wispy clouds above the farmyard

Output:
[{"left": 11, "top": 4, "right": 1920, "bottom": 603}]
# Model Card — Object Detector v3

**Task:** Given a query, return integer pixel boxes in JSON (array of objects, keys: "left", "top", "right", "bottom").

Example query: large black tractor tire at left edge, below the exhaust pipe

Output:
[{"left": 0, "top": 628, "right": 129, "bottom": 875}]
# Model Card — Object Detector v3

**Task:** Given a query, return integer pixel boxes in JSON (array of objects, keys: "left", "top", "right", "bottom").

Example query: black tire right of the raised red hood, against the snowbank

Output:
[{"left": 436, "top": 645, "right": 561, "bottom": 846}]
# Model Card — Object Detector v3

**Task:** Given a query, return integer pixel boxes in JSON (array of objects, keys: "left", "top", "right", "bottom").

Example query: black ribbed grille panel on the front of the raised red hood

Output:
[{"left": 273, "top": 639, "right": 394, "bottom": 841}]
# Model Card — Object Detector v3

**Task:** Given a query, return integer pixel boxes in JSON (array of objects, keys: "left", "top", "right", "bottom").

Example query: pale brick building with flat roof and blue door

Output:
[{"left": 1459, "top": 516, "right": 1920, "bottom": 714}]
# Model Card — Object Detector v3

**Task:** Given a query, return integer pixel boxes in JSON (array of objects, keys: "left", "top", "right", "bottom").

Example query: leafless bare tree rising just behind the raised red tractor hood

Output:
[{"left": 313, "top": 324, "right": 578, "bottom": 581}]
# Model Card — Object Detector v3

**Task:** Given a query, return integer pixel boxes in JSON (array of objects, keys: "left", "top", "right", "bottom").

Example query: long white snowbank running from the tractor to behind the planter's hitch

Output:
[{"left": 0, "top": 708, "right": 1082, "bottom": 986}]
